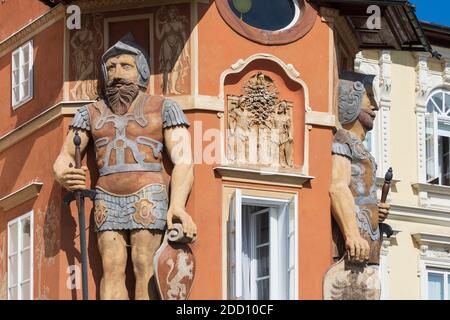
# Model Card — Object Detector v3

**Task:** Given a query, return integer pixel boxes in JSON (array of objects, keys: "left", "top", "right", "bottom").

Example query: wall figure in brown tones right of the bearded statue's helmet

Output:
[{"left": 156, "top": 6, "right": 189, "bottom": 95}]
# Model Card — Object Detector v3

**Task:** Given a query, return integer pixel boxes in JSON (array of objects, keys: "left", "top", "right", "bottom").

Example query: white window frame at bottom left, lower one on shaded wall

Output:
[{"left": 7, "top": 211, "right": 34, "bottom": 300}]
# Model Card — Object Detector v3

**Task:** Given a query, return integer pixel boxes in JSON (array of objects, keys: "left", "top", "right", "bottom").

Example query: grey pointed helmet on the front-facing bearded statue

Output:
[{"left": 102, "top": 32, "right": 150, "bottom": 88}]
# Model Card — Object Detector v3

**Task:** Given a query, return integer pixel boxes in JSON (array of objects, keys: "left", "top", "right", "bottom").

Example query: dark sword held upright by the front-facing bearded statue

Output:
[{"left": 64, "top": 131, "right": 95, "bottom": 300}]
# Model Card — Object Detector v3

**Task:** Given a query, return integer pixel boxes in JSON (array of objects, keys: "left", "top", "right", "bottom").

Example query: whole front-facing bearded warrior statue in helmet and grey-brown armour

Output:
[{"left": 54, "top": 34, "right": 197, "bottom": 299}]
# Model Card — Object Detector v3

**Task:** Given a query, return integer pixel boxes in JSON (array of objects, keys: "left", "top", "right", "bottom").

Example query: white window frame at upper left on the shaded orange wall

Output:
[{"left": 11, "top": 40, "right": 33, "bottom": 110}]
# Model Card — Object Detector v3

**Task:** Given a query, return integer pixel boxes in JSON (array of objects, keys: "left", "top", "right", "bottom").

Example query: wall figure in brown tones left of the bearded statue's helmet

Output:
[{"left": 70, "top": 16, "right": 103, "bottom": 100}]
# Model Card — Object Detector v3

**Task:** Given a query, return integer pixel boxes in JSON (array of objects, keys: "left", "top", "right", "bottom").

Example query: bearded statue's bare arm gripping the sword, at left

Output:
[{"left": 53, "top": 129, "right": 89, "bottom": 191}]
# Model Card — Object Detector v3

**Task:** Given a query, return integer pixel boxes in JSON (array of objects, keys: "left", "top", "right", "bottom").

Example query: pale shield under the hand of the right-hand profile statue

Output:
[{"left": 323, "top": 255, "right": 381, "bottom": 300}]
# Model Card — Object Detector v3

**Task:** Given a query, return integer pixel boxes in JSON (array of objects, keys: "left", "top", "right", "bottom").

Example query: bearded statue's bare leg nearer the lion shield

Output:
[{"left": 131, "top": 230, "right": 163, "bottom": 300}]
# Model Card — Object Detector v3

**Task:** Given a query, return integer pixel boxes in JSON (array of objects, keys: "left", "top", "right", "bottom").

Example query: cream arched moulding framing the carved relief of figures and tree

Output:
[{"left": 219, "top": 53, "right": 312, "bottom": 176}]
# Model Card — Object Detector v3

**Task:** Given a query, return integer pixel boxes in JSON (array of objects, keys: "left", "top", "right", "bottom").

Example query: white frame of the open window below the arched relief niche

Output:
[{"left": 227, "top": 189, "right": 298, "bottom": 300}]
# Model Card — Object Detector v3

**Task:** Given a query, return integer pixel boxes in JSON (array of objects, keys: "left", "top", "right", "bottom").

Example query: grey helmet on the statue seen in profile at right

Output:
[{"left": 338, "top": 71, "right": 378, "bottom": 125}]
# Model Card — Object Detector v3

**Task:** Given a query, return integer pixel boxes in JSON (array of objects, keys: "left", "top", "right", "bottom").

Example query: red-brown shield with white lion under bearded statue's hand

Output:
[{"left": 153, "top": 224, "right": 195, "bottom": 300}]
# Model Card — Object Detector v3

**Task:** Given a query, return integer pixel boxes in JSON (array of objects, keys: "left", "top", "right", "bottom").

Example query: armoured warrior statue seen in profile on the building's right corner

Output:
[{"left": 325, "top": 72, "right": 390, "bottom": 299}]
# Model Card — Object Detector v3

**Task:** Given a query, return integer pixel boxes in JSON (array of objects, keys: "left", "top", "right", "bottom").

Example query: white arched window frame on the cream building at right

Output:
[{"left": 425, "top": 89, "right": 450, "bottom": 185}]
